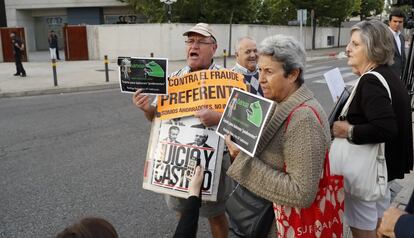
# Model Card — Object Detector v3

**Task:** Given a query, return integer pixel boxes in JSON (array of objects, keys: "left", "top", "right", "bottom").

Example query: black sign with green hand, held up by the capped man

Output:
[{"left": 118, "top": 57, "right": 168, "bottom": 95}]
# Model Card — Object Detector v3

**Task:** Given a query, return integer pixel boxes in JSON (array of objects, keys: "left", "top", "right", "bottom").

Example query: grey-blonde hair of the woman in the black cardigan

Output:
[{"left": 351, "top": 20, "right": 394, "bottom": 65}]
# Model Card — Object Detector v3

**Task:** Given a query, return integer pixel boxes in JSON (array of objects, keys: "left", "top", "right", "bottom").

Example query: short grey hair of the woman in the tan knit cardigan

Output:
[{"left": 258, "top": 35, "right": 306, "bottom": 86}]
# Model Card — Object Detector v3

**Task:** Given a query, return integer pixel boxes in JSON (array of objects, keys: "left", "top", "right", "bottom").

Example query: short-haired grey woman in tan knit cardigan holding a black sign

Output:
[{"left": 226, "top": 35, "right": 330, "bottom": 237}]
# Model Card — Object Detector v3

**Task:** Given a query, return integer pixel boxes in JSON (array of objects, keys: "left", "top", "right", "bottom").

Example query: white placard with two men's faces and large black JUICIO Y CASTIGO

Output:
[{"left": 143, "top": 117, "right": 224, "bottom": 201}]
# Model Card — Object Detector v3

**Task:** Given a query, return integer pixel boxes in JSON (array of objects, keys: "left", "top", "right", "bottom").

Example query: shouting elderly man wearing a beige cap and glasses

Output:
[{"left": 132, "top": 23, "right": 230, "bottom": 237}]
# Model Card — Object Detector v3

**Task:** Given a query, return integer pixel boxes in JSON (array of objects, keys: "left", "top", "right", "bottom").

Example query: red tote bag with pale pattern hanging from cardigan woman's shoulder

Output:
[{"left": 273, "top": 105, "right": 345, "bottom": 238}]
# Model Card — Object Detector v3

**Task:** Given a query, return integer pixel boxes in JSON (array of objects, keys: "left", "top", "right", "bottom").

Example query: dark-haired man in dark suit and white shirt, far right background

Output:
[{"left": 388, "top": 8, "right": 406, "bottom": 78}]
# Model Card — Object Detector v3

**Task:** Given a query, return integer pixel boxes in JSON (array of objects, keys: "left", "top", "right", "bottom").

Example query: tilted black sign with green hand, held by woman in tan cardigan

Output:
[{"left": 217, "top": 88, "right": 273, "bottom": 157}]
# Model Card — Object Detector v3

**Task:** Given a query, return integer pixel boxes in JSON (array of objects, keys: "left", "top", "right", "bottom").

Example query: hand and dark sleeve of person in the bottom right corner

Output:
[{"left": 378, "top": 191, "right": 414, "bottom": 238}]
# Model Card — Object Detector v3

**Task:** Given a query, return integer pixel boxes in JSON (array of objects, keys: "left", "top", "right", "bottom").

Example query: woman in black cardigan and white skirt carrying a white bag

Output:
[{"left": 331, "top": 20, "right": 413, "bottom": 238}]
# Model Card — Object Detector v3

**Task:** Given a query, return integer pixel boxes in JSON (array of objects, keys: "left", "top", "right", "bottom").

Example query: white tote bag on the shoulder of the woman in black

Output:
[{"left": 329, "top": 71, "right": 391, "bottom": 201}]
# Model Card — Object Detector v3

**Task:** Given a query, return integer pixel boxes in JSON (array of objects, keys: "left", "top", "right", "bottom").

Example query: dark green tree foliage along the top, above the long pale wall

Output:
[{"left": 119, "top": 0, "right": 360, "bottom": 25}]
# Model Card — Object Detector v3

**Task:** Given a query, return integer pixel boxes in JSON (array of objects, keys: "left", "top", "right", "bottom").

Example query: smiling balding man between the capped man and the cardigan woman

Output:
[{"left": 231, "top": 36, "right": 263, "bottom": 96}]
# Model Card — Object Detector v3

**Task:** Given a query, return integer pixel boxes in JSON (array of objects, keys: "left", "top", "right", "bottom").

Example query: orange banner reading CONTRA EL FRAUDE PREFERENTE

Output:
[{"left": 157, "top": 69, "right": 246, "bottom": 120}]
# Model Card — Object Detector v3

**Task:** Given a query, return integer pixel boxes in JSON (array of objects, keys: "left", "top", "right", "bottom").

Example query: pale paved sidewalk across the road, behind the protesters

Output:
[{"left": 0, "top": 47, "right": 344, "bottom": 98}]
